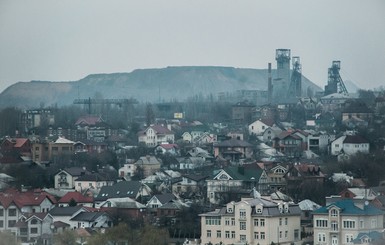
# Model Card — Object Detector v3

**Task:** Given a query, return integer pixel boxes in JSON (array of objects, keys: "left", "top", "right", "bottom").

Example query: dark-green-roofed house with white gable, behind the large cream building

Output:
[{"left": 206, "top": 164, "right": 268, "bottom": 204}]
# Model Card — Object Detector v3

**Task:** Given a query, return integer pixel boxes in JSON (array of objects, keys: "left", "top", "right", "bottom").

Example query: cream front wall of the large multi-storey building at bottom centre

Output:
[{"left": 201, "top": 201, "right": 300, "bottom": 245}]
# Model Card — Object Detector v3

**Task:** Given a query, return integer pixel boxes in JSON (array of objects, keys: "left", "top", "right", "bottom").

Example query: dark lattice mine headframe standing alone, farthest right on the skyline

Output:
[{"left": 325, "top": 60, "right": 348, "bottom": 95}]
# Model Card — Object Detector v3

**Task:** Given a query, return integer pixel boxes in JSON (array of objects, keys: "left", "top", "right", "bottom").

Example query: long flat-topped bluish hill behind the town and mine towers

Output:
[{"left": 0, "top": 66, "right": 321, "bottom": 108}]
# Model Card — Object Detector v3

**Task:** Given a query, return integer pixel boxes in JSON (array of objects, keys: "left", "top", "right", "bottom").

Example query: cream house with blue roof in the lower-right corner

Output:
[{"left": 313, "top": 199, "right": 384, "bottom": 245}]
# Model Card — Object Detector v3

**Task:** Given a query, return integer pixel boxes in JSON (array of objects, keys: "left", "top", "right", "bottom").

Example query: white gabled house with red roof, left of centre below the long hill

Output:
[{"left": 138, "top": 125, "right": 175, "bottom": 147}]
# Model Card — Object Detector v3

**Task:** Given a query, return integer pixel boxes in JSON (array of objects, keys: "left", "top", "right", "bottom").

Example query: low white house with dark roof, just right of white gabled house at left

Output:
[{"left": 74, "top": 173, "right": 115, "bottom": 193}]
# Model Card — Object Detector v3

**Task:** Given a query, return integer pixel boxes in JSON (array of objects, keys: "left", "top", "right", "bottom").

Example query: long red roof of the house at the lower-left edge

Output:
[{"left": 0, "top": 189, "right": 56, "bottom": 208}]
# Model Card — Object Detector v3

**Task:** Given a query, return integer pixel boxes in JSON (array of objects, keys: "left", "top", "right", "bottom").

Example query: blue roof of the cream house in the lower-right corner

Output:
[{"left": 313, "top": 199, "right": 384, "bottom": 215}]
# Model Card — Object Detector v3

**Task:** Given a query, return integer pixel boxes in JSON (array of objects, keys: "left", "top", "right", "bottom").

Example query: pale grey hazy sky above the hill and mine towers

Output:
[{"left": 0, "top": 0, "right": 385, "bottom": 91}]
